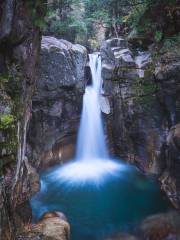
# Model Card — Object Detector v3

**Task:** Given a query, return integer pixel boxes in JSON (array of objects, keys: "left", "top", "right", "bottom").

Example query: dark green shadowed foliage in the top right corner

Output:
[{"left": 127, "top": 0, "right": 179, "bottom": 43}]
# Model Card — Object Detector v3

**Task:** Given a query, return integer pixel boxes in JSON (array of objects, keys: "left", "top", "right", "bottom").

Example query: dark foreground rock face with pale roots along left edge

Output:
[{"left": 0, "top": 0, "right": 45, "bottom": 240}]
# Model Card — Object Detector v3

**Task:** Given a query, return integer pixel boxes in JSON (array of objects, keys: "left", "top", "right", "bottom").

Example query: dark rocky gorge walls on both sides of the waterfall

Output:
[{"left": 0, "top": 0, "right": 180, "bottom": 240}]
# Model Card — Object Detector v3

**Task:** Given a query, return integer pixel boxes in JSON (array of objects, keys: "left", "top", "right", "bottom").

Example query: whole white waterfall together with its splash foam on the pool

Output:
[{"left": 47, "top": 54, "right": 122, "bottom": 186}]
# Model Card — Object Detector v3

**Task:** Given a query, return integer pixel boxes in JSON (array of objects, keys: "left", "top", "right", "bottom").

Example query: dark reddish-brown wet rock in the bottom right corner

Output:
[{"left": 141, "top": 212, "right": 180, "bottom": 240}]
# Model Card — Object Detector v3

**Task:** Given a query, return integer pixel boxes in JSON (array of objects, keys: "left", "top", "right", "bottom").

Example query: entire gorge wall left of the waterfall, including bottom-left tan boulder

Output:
[{"left": 0, "top": 1, "right": 87, "bottom": 234}]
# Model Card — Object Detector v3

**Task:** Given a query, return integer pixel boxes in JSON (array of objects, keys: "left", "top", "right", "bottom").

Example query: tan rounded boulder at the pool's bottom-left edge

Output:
[{"left": 17, "top": 212, "right": 70, "bottom": 240}]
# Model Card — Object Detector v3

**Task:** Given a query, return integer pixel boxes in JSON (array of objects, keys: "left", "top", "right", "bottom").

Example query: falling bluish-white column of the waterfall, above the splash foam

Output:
[{"left": 76, "top": 54, "right": 108, "bottom": 161}]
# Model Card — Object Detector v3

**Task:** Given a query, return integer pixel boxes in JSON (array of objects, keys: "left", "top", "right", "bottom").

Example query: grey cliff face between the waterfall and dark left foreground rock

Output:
[{"left": 28, "top": 37, "right": 87, "bottom": 168}]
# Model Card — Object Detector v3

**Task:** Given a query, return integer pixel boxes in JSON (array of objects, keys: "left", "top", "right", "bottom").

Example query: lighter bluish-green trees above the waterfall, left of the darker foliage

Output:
[{"left": 46, "top": 0, "right": 150, "bottom": 41}]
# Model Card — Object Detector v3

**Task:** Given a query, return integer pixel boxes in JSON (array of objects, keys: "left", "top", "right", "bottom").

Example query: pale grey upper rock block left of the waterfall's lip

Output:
[{"left": 36, "top": 36, "right": 87, "bottom": 94}]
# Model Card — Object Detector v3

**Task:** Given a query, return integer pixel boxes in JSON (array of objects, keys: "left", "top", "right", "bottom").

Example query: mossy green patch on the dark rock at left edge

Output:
[{"left": 0, "top": 64, "right": 24, "bottom": 169}]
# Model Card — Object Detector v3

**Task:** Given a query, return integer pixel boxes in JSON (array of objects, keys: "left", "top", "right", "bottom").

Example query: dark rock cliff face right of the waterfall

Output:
[{"left": 101, "top": 39, "right": 180, "bottom": 207}]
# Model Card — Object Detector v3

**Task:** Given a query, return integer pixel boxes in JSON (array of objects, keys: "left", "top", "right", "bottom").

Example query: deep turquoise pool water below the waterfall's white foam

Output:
[{"left": 31, "top": 163, "right": 169, "bottom": 240}]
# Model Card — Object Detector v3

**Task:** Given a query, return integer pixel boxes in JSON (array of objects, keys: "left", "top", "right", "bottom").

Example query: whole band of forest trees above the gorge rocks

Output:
[{"left": 42, "top": 0, "right": 180, "bottom": 46}]
